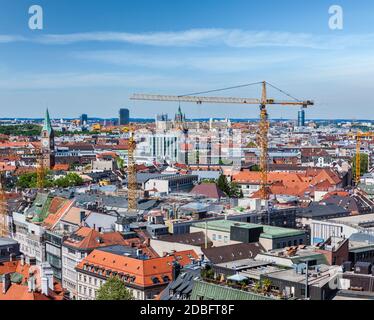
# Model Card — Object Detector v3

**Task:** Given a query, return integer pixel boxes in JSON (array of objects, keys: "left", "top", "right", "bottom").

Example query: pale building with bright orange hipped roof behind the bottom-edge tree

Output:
[{"left": 76, "top": 247, "right": 198, "bottom": 300}]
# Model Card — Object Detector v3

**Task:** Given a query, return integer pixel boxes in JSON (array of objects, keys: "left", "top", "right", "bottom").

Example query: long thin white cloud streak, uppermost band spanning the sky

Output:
[{"left": 0, "top": 28, "right": 374, "bottom": 49}]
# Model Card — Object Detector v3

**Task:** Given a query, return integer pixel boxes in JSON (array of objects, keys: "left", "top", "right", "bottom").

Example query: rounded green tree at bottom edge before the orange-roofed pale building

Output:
[{"left": 96, "top": 277, "right": 134, "bottom": 301}]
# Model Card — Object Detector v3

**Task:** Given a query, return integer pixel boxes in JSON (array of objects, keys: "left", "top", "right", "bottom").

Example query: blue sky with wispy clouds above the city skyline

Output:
[{"left": 0, "top": 0, "right": 374, "bottom": 119}]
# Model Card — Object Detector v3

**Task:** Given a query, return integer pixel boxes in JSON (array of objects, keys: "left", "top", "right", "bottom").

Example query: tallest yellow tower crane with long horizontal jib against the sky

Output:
[{"left": 130, "top": 81, "right": 314, "bottom": 200}]
